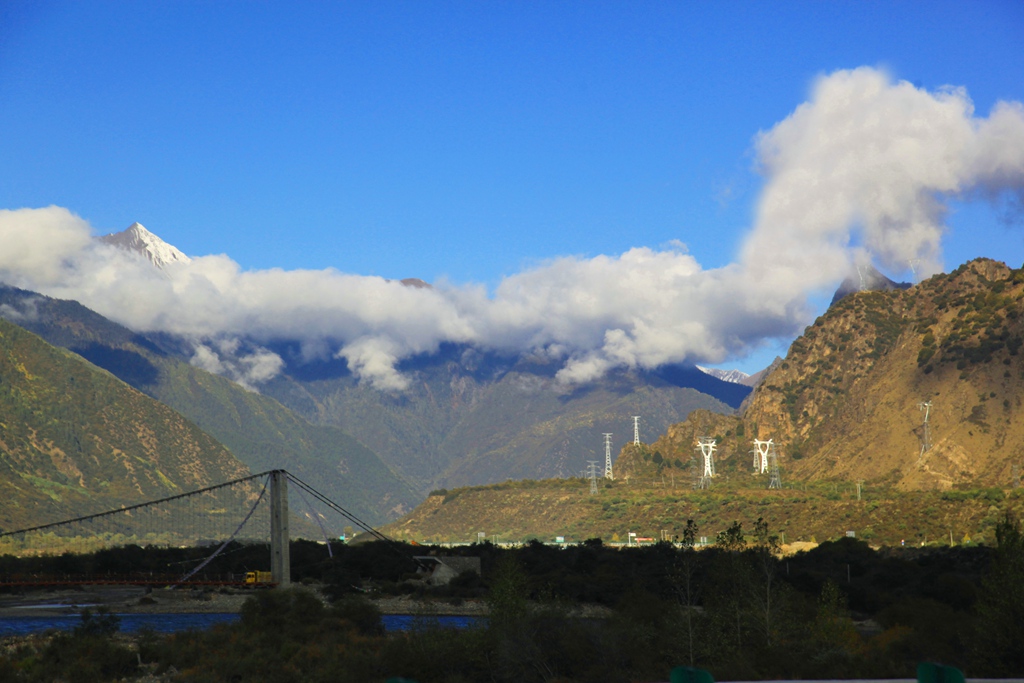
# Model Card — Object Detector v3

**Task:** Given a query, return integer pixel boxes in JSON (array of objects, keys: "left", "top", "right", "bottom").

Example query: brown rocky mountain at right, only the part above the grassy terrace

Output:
[{"left": 617, "top": 259, "right": 1024, "bottom": 490}]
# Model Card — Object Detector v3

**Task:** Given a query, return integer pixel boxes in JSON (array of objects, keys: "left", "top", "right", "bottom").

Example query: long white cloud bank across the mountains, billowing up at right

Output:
[{"left": 0, "top": 68, "right": 1024, "bottom": 390}]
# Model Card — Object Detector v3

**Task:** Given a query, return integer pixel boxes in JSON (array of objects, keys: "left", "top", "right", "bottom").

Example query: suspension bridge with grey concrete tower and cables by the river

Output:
[{"left": 0, "top": 470, "right": 391, "bottom": 586}]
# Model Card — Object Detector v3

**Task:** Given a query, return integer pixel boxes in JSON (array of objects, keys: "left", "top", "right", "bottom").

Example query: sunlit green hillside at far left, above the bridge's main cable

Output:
[{"left": 0, "top": 319, "right": 249, "bottom": 529}]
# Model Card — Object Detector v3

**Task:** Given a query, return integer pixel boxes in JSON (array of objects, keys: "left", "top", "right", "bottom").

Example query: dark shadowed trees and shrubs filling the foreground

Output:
[{"left": 0, "top": 515, "right": 1024, "bottom": 683}]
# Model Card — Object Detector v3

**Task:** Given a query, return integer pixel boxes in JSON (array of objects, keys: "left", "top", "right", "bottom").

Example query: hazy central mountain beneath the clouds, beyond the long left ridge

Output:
[{"left": 85, "top": 228, "right": 750, "bottom": 494}]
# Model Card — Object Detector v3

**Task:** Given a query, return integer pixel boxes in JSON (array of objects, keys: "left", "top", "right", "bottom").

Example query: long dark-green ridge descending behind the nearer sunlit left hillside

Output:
[{"left": 0, "top": 287, "right": 419, "bottom": 523}]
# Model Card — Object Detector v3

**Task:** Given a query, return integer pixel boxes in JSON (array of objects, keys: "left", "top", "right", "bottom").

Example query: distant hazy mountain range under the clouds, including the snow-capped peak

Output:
[{"left": 0, "top": 223, "right": 774, "bottom": 522}]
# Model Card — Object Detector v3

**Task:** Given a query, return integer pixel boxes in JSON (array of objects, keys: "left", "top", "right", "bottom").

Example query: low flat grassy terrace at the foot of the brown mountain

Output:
[{"left": 384, "top": 469, "right": 1024, "bottom": 547}]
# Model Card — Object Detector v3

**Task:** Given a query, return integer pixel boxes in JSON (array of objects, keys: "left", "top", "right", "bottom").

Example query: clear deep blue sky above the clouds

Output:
[{"left": 0, "top": 0, "right": 1024, "bottom": 370}]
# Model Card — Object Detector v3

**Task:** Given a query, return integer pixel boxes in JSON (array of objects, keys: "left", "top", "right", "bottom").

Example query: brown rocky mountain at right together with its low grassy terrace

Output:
[{"left": 387, "top": 254, "right": 1024, "bottom": 545}]
